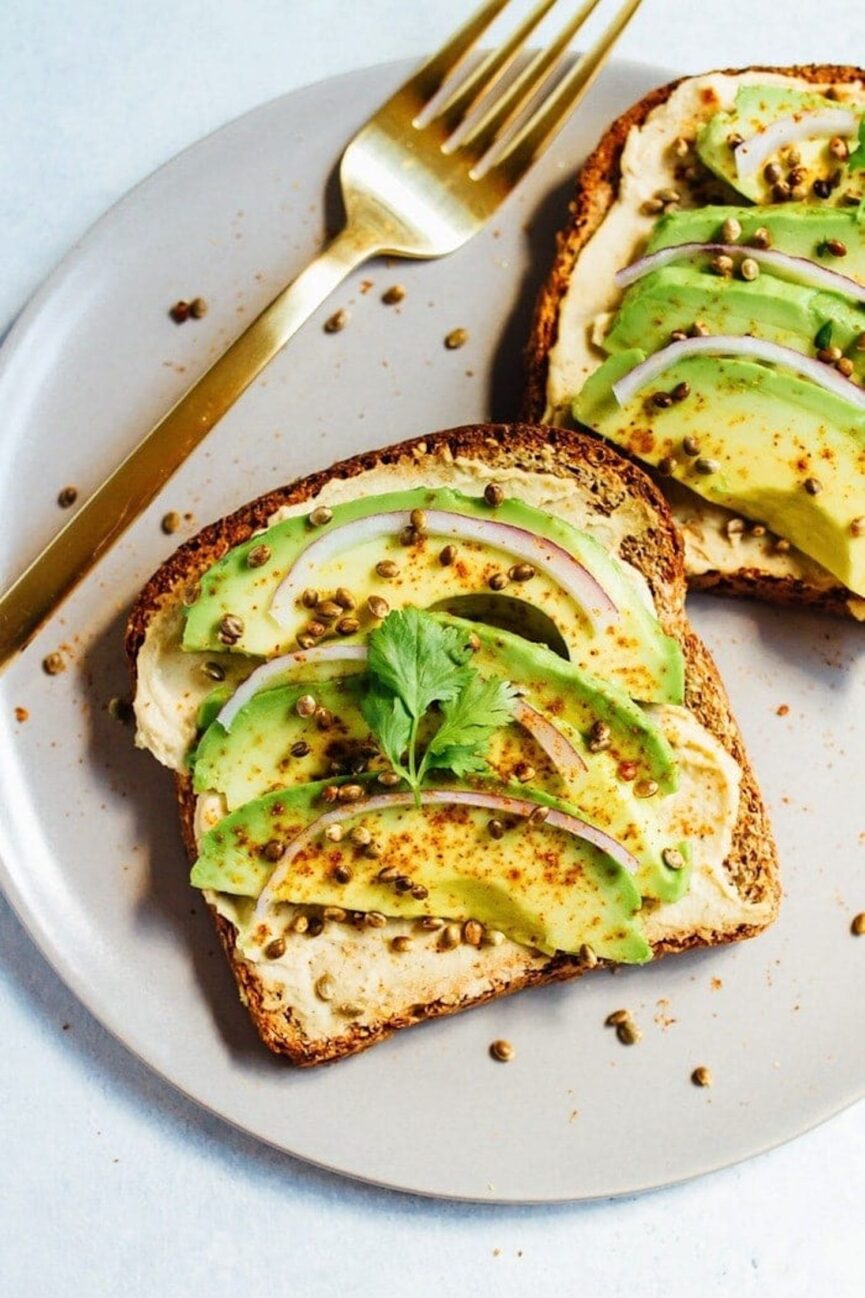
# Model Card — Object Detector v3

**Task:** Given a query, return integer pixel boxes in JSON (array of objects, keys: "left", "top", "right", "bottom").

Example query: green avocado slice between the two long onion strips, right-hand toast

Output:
[{"left": 604, "top": 258, "right": 865, "bottom": 375}]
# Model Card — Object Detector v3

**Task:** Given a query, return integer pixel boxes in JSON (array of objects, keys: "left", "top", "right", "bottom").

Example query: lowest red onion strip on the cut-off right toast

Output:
[{"left": 613, "top": 334, "right": 865, "bottom": 410}]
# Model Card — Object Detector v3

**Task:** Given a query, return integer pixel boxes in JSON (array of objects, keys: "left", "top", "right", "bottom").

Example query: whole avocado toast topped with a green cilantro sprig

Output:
[{"left": 127, "top": 424, "right": 778, "bottom": 1064}]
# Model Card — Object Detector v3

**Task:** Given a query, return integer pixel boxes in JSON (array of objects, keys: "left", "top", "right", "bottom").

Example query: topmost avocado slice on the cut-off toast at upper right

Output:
[{"left": 696, "top": 86, "right": 852, "bottom": 202}]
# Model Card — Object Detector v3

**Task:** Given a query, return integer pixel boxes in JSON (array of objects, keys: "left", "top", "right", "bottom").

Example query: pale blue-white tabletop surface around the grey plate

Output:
[{"left": 0, "top": 0, "right": 865, "bottom": 1298}]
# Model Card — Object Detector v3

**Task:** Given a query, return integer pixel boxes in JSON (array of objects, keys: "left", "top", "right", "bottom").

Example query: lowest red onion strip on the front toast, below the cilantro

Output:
[{"left": 252, "top": 789, "right": 639, "bottom": 929}]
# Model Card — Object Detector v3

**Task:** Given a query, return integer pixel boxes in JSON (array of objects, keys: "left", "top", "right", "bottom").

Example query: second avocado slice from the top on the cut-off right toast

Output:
[{"left": 646, "top": 202, "right": 865, "bottom": 284}]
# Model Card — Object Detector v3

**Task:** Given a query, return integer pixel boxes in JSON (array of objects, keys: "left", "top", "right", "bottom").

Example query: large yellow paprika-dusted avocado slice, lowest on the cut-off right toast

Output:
[{"left": 573, "top": 350, "right": 865, "bottom": 596}]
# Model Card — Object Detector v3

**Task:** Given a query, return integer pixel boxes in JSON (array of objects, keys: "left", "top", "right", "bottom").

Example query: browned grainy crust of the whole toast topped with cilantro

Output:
[{"left": 126, "top": 424, "right": 779, "bottom": 1066}]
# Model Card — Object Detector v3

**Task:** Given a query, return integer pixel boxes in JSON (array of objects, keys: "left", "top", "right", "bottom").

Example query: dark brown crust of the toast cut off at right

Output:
[{"left": 522, "top": 64, "right": 865, "bottom": 620}]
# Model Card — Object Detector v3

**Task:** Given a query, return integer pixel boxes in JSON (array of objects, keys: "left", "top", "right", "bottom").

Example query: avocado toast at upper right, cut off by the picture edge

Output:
[{"left": 525, "top": 66, "right": 865, "bottom": 620}]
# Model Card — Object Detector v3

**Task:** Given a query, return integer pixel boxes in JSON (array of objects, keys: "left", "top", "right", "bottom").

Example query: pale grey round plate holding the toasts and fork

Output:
[{"left": 0, "top": 64, "right": 865, "bottom": 1202}]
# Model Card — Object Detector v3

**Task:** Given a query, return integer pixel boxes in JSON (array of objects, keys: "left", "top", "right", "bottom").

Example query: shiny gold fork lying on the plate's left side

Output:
[{"left": 0, "top": 0, "right": 642, "bottom": 670}]
